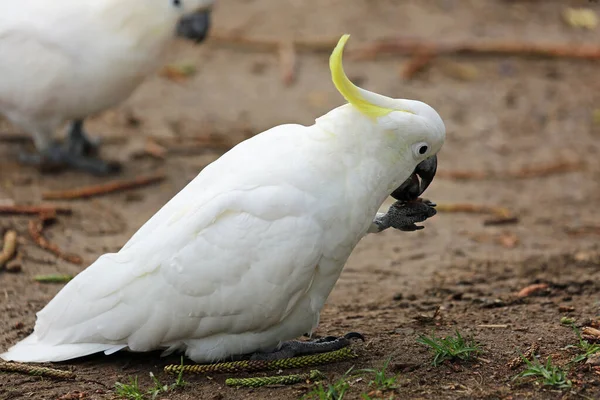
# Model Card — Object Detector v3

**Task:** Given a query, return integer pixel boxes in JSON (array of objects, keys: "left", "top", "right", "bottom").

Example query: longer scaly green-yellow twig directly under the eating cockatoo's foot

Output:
[{"left": 165, "top": 346, "right": 358, "bottom": 374}]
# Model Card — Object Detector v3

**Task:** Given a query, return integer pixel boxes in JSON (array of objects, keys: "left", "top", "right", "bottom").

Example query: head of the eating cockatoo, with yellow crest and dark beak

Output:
[{"left": 329, "top": 35, "right": 446, "bottom": 201}]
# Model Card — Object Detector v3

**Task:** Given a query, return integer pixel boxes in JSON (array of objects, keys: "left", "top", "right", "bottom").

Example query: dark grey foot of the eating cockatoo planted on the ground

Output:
[{"left": 250, "top": 332, "right": 365, "bottom": 361}]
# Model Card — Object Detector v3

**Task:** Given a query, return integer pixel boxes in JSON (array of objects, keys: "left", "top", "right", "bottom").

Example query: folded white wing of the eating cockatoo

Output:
[{"left": 12, "top": 186, "right": 323, "bottom": 362}]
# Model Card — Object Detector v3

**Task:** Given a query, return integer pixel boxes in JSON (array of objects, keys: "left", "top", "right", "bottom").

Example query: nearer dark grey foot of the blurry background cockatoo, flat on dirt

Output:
[{"left": 19, "top": 144, "right": 120, "bottom": 175}]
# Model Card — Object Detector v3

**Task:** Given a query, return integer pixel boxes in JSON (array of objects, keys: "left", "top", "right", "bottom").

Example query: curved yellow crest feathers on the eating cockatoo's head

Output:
[{"left": 329, "top": 35, "right": 396, "bottom": 118}]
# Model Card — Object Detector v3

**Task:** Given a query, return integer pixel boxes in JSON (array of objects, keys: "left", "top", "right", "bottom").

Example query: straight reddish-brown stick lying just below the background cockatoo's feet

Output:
[{"left": 42, "top": 174, "right": 166, "bottom": 200}]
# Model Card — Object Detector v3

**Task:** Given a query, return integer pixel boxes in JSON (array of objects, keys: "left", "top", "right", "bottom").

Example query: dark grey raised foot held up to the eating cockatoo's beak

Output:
[{"left": 369, "top": 200, "right": 437, "bottom": 233}]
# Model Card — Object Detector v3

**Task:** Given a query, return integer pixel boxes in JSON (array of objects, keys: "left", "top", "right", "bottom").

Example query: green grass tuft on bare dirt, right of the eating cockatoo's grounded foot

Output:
[{"left": 417, "top": 330, "right": 483, "bottom": 366}]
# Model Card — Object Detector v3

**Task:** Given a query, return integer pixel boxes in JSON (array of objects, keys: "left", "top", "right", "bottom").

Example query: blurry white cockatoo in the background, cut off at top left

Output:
[{"left": 0, "top": 0, "right": 214, "bottom": 174}]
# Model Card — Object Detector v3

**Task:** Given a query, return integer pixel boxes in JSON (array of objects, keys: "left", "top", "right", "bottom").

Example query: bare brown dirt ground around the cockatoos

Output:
[{"left": 0, "top": 0, "right": 600, "bottom": 400}]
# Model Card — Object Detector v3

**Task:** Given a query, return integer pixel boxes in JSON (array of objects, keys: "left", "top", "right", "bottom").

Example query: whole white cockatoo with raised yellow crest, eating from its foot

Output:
[{"left": 0, "top": 35, "right": 445, "bottom": 362}]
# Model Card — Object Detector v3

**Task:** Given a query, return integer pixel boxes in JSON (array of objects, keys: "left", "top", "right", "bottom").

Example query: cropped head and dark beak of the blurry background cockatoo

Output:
[{"left": 171, "top": 0, "right": 214, "bottom": 43}]
